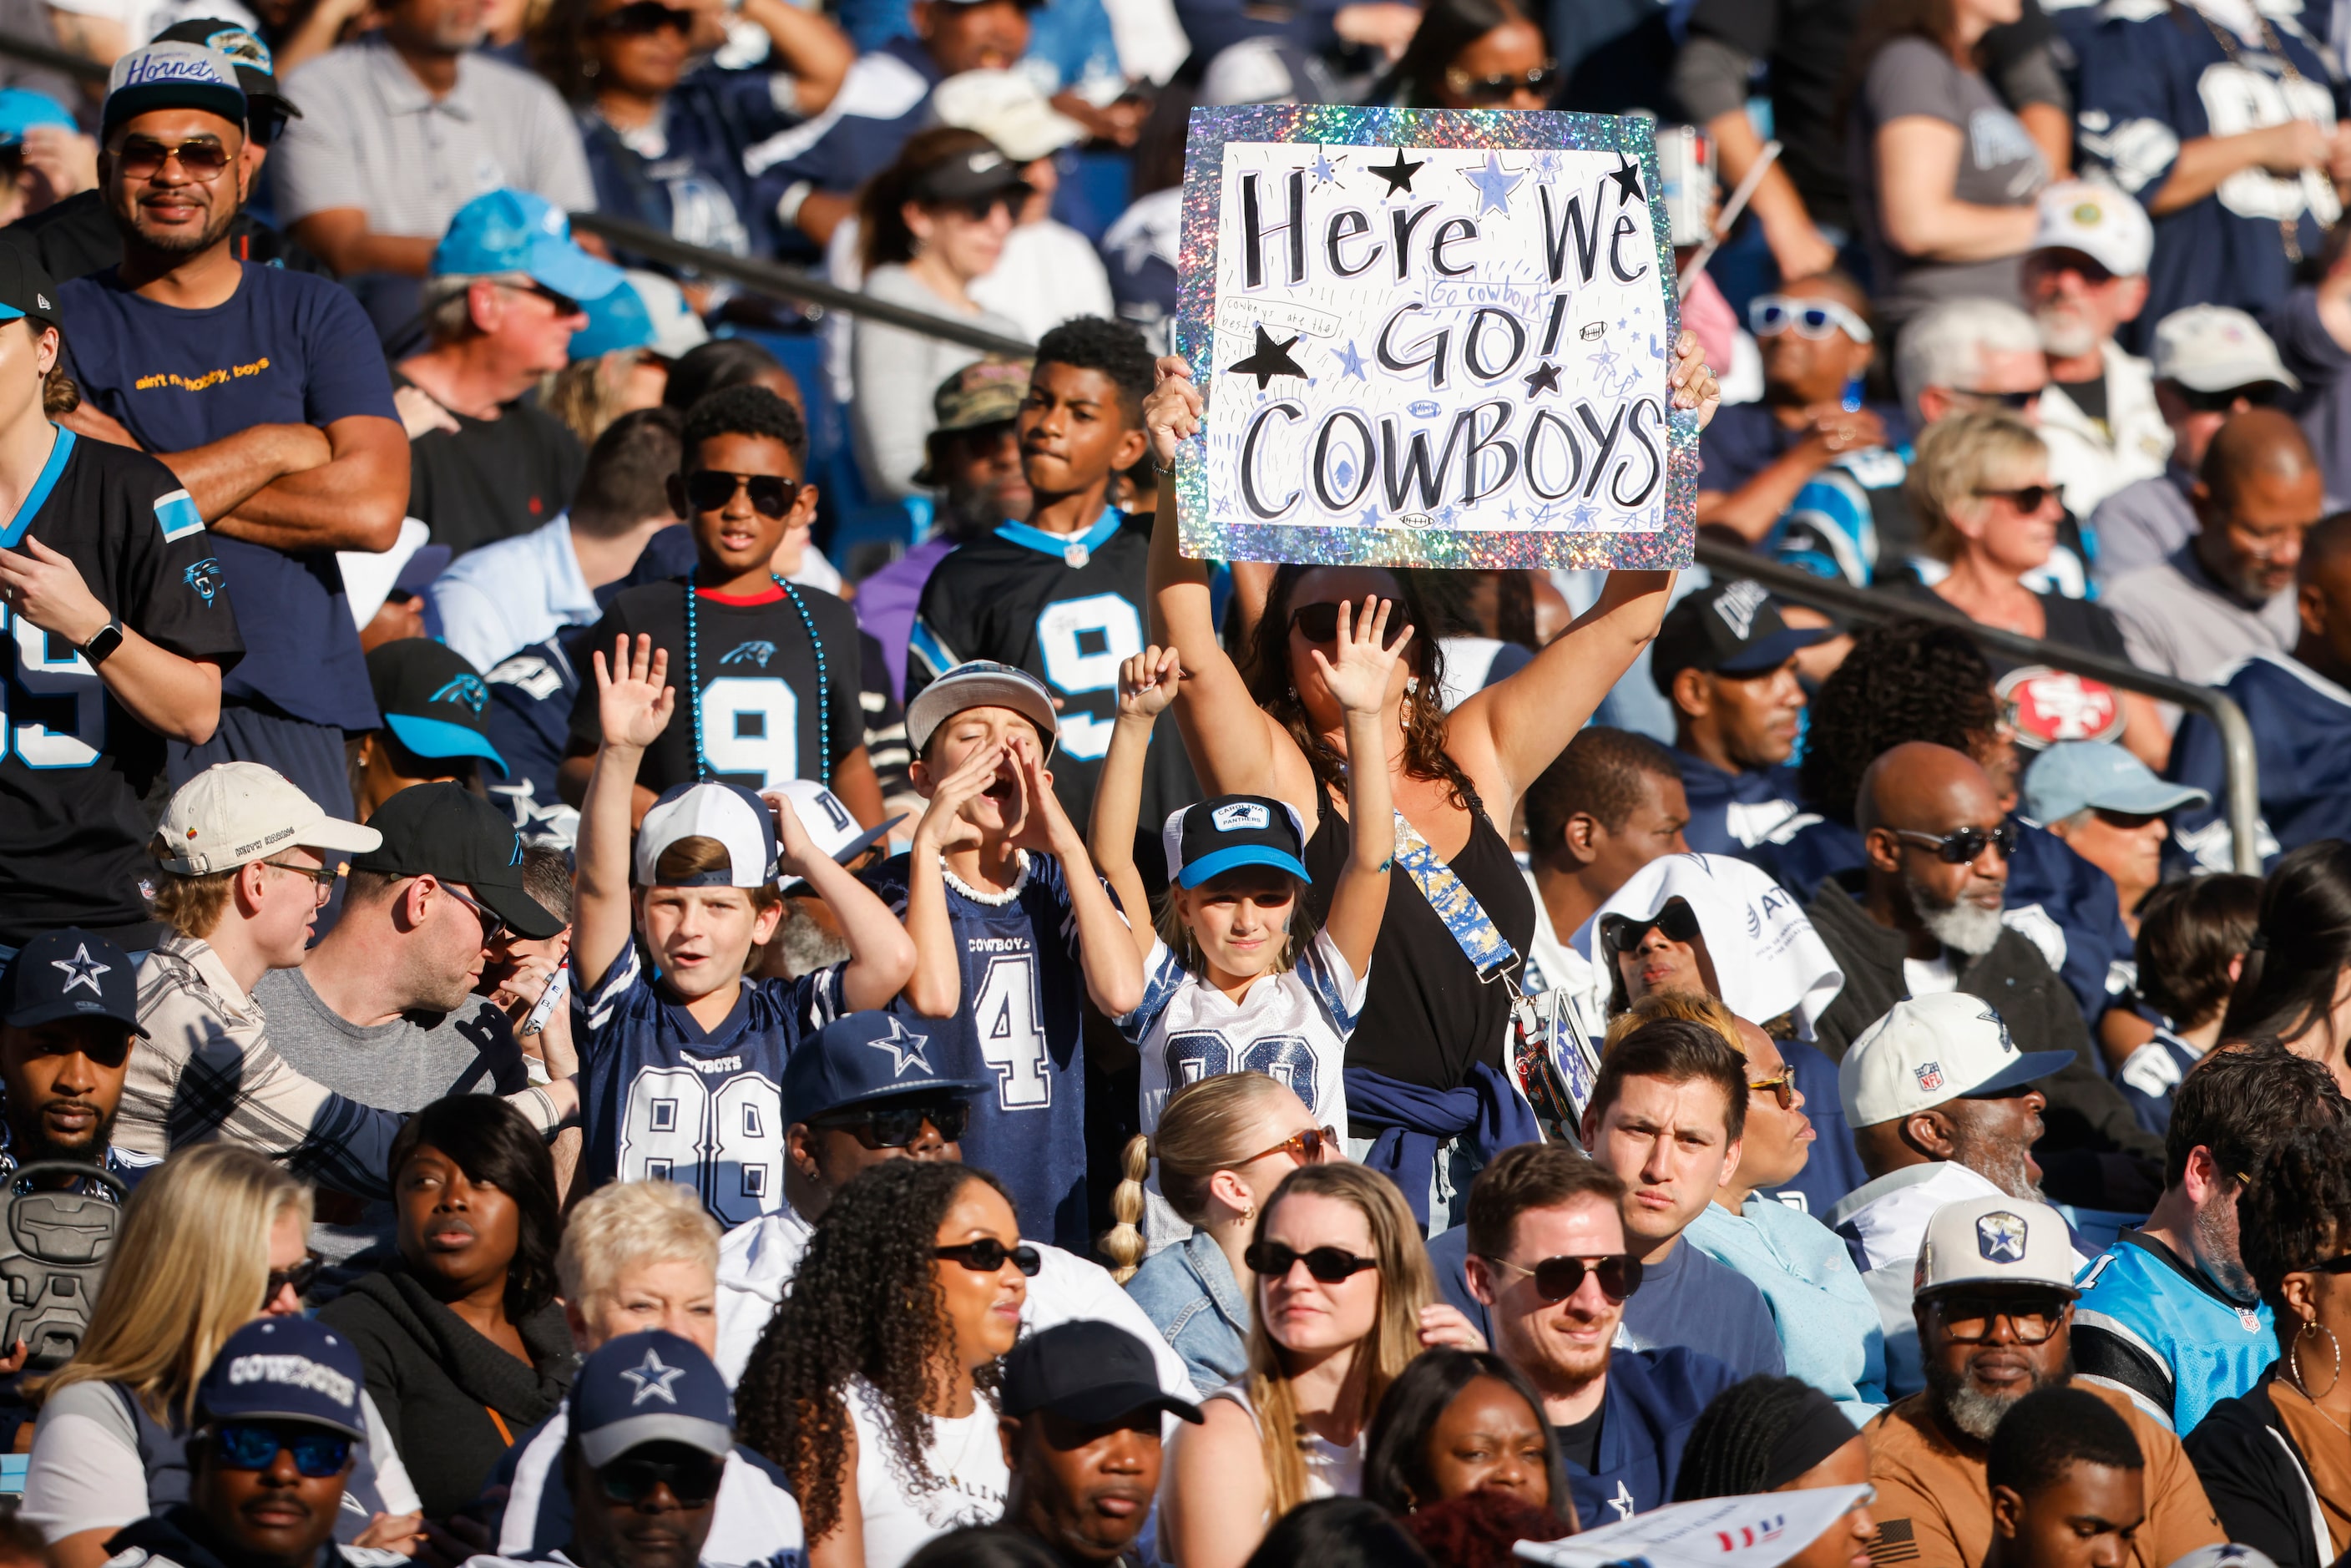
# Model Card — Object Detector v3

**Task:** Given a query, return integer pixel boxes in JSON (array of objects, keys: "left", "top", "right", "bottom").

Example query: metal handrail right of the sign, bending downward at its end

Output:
[{"left": 1697, "top": 536, "right": 2262, "bottom": 877}]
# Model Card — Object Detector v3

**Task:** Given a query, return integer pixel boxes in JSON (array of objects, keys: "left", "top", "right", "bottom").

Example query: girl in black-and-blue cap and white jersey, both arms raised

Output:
[{"left": 1089, "top": 615, "right": 1413, "bottom": 1246}]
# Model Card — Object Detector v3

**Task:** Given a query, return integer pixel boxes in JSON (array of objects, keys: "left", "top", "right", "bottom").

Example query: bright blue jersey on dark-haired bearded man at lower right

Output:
[{"left": 2074, "top": 1232, "right": 2278, "bottom": 1436}]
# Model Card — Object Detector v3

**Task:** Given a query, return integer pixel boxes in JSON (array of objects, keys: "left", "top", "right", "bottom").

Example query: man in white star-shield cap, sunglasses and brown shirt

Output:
[{"left": 1867, "top": 1194, "right": 2227, "bottom": 1568}]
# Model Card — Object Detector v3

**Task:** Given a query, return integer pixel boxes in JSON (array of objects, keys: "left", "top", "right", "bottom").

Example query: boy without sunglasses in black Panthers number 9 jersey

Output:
[{"left": 902, "top": 317, "right": 1199, "bottom": 822}]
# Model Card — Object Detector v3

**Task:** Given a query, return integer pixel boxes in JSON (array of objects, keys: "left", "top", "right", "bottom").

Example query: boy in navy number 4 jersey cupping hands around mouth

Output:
[{"left": 867, "top": 658, "right": 1143, "bottom": 1256}]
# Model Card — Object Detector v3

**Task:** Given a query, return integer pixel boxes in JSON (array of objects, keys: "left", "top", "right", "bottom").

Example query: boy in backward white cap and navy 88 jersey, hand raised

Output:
[{"left": 571, "top": 632, "right": 914, "bottom": 1227}]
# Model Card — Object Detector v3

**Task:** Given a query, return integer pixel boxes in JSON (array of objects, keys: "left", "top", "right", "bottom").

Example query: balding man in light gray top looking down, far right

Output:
[{"left": 2104, "top": 409, "right": 2325, "bottom": 690}]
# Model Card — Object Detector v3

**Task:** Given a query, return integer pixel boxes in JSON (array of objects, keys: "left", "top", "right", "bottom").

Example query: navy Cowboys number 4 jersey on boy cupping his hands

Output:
[{"left": 865, "top": 856, "right": 1093, "bottom": 1257}]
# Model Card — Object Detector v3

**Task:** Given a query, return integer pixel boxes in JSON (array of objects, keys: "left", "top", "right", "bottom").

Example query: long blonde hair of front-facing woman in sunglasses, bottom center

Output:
[{"left": 1246, "top": 1164, "right": 1437, "bottom": 1519}]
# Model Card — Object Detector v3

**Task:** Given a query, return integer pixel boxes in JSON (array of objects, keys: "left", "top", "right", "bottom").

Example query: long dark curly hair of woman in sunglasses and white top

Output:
[{"left": 736, "top": 1159, "right": 1011, "bottom": 1540}]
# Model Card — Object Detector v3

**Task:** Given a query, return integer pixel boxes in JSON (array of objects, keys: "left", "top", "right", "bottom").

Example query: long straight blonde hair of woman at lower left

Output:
[{"left": 33, "top": 1142, "right": 311, "bottom": 1427}]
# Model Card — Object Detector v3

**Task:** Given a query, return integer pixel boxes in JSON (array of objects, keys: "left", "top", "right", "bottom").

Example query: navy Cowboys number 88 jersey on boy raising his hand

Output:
[{"left": 571, "top": 943, "right": 847, "bottom": 1230}]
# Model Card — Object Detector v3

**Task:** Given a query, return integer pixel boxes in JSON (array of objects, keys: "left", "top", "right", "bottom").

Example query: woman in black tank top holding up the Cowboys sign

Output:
[{"left": 1143, "top": 331, "right": 1716, "bottom": 1230}]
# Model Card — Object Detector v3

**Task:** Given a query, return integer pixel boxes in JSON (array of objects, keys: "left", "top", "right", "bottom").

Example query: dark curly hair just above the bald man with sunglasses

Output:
[{"left": 1796, "top": 619, "right": 2000, "bottom": 827}]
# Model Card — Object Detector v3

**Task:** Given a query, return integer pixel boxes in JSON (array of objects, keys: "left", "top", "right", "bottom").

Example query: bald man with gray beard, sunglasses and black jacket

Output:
[{"left": 1810, "top": 741, "right": 2163, "bottom": 1171}]
